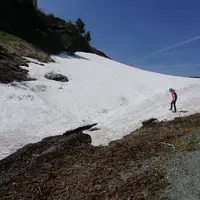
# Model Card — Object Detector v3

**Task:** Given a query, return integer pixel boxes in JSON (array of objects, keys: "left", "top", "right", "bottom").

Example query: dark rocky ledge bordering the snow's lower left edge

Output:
[{"left": 0, "top": 124, "right": 96, "bottom": 185}]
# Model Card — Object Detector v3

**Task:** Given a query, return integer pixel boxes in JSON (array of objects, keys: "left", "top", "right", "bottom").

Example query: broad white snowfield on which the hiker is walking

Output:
[{"left": 0, "top": 53, "right": 200, "bottom": 159}]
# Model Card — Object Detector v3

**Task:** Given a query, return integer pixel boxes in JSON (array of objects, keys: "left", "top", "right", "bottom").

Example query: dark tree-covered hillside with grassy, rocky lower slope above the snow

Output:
[{"left": 0, "top": 0, "right": 109, "bottom": 83}]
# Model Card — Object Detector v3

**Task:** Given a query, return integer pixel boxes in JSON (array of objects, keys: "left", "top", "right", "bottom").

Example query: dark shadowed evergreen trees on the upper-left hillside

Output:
[{"left": 0, "top": 0, "right": 94, "bottom": 53}]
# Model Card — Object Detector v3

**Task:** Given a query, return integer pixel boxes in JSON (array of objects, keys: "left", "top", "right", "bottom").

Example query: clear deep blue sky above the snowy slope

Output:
[{"left": 38, "top": 0, "right": 200, "bottom": 76}]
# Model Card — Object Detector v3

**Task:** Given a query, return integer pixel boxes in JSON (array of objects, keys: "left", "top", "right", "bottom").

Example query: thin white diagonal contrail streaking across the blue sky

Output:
[{"left": 131, "top": 35, "right": 200, "bottom": 64}]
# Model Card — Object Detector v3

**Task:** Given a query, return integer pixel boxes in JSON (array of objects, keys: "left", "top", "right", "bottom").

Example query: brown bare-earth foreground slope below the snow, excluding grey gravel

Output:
[{"left": 0, "top": 114, "right": 200, "bottom": 200}]
